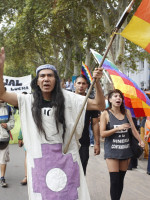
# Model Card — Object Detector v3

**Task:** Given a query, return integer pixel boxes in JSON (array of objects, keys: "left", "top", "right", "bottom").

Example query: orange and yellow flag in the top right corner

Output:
[{"left": 121, "top": 0, "right": 150, "bottom": 53}]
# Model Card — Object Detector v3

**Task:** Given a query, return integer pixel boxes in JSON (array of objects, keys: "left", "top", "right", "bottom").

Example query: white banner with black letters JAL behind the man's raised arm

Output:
[{"left": 3, "top": 75, "right": 31, "bottom": 93}]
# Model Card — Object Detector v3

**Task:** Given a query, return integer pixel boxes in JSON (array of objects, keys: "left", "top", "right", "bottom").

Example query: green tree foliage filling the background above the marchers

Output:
[{"left": 0, "top": 0, "right": 148, "bottom": 77}]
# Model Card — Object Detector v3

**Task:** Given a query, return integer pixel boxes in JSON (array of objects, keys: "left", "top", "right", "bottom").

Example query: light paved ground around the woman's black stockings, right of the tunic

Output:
[{"left": 86, "top": 144, "right": 150, "bottom": 200}]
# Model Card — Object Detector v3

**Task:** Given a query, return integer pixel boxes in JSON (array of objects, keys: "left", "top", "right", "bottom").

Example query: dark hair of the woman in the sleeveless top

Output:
[{"left": 107, "top": 89, "right": 126, "bottom": 115}]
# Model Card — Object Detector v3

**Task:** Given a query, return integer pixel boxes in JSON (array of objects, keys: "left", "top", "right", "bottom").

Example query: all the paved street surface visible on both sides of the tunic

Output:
[{"left": 0, "top": 145, "right": 150, "bottom": 200}]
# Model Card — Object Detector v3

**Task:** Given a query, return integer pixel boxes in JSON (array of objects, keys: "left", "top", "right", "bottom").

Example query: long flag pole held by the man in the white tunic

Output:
[{"left": 63, "top": 0, "right": 135, "bottom": 154}]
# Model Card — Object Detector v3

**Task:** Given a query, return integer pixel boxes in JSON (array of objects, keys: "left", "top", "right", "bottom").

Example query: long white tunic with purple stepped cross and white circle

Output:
[{"left": 18, "top": 90, "right": 90, "bottom": 200}]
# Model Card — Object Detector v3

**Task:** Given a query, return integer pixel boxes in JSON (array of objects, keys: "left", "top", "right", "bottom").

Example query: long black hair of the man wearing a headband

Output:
[{"left": 31, "top": 71, "right": 66, "bottom": 140}]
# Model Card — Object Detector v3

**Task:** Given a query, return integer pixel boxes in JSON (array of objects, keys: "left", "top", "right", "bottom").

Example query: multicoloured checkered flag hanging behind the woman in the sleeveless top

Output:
[{"left": 91, "top": 50, "right": 150, "bottom": 117}]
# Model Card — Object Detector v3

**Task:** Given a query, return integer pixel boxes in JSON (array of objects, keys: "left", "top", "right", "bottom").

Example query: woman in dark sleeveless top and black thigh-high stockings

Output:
[{"left": 100, "top": 89, "right": 144, "bottom": 200}]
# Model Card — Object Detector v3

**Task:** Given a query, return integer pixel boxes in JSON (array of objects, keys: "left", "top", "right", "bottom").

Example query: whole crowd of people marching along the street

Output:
[{"left": 0, "top": 48, "right": 150, "bottom": 200}]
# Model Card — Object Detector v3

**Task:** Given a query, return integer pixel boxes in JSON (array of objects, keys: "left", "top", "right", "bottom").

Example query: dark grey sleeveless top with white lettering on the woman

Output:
[{"left": 104, "top": 111, "right": 133, "bottom": 159}]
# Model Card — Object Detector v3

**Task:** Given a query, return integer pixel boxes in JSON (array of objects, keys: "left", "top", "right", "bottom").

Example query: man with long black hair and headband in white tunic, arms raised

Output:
[{"left": 0, "top": 48, "right": 105, "bottom": 200}]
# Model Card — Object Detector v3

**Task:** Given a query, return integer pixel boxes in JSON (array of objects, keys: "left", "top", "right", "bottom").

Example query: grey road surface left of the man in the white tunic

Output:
[{"left": 0, "top": 144, "right": 28, "bottom": 200}]
